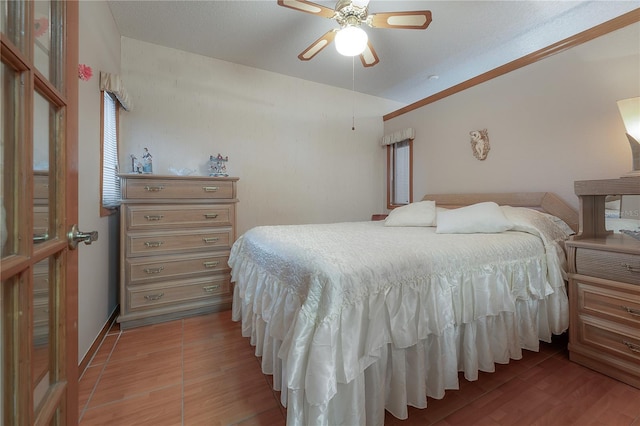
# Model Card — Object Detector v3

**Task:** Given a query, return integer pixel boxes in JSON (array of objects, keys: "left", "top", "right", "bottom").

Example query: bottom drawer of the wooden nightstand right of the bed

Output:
[{"left": 577, "top": 315, "right": 640, "bottom": 362}]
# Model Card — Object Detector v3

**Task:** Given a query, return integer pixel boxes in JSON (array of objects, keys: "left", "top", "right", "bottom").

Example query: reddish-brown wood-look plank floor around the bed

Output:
[{"left": 79, "top": 311, "right": 640, "bottom": 426}]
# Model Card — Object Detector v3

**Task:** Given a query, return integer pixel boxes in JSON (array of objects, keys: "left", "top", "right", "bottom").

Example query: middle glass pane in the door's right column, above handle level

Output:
[{"left": 33, "top": 92, "right": 55, "bottom": 244}]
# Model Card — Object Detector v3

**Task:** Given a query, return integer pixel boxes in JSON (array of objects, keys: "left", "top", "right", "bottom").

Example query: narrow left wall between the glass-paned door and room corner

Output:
[{"left": 78, "top": 1, "right": 120, "bottom": 361}]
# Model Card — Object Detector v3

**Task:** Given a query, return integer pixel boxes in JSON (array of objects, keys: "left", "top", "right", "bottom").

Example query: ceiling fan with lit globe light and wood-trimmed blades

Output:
[{"left": 278, "top": 0, "right": 431, "bottom": 67}]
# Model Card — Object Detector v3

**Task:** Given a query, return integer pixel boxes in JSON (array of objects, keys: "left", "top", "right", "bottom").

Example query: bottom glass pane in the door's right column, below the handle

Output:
[{"left": 31, "top": 258, "right": 55, "bottom": 408}]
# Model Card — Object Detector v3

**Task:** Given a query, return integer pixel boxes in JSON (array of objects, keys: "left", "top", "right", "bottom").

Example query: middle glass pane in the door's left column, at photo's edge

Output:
[{"left": 0, "top": 63, "right": 20, "bottom": 257}]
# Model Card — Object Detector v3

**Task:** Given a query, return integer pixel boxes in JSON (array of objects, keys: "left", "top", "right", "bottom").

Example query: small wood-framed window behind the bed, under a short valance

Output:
[{"left": 387, "top": 139, "right": 413, "bottom": 209}]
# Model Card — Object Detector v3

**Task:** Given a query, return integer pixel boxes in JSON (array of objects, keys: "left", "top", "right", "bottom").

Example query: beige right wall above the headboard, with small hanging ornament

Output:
[{"left": 384, "top": 24, "right": 640, "bottom": 208}]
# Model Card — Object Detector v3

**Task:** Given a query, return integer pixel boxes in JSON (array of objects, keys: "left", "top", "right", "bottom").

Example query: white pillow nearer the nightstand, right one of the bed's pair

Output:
[{"left": 436, "top": 201, "right": 513, "bottom": 234}]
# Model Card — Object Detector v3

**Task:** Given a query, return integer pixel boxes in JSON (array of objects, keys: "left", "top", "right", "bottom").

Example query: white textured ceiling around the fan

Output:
[{"left": 109, "top": 0, "right": 640, "bottom": 104}]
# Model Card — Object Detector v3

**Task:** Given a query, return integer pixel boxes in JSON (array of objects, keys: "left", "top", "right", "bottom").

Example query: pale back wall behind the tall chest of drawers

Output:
[{"left": 120, "top": 37, "right": 402, "bottom": 235}]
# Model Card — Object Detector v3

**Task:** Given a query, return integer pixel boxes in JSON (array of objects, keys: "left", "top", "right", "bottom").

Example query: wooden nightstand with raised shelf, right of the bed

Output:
[{"left": 566, "top": 177, "right": 640, "bottom": 388}]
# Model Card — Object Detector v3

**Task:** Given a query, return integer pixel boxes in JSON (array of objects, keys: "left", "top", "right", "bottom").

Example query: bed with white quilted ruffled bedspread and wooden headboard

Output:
[{"left": 229, "top": 192, "right": 578, "bottom": 426}]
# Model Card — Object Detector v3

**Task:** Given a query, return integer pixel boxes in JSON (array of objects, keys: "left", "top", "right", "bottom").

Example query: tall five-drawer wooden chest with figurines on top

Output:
[{"left": 118, "top": 174, "right": 238, "bottom": 329}]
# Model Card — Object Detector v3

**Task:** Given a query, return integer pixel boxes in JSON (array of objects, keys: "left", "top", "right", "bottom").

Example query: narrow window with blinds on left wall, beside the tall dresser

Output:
[{"left": 100, "top": 91, "right": 120, "bottom": 216}]
